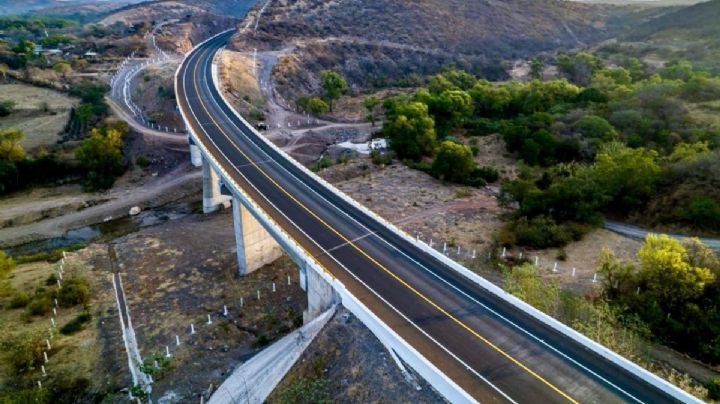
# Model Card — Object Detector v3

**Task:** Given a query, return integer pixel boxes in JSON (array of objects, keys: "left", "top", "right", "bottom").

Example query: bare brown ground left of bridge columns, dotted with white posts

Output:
[{"left": 111, "top": 211, "right": 307, "bottom": 402}]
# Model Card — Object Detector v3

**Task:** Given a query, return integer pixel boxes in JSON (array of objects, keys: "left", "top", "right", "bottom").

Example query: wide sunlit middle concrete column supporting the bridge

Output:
[{"left": 232, "top": 196, "right": 283, "bottom": 276}]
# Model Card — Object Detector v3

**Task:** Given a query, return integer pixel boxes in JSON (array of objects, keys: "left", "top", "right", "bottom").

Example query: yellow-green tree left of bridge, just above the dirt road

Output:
[{"left": 75, "top": 128, "right": 125, "bottom": 190}]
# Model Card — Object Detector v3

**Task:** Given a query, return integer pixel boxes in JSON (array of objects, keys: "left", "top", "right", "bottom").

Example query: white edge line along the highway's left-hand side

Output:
[{"left": 185, "top": 41, "right": 517, "bottom": 404}]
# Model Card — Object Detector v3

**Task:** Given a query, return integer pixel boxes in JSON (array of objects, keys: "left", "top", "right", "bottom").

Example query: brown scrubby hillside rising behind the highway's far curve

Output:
[{"left": 233, "top": 0, "right": 660, "bottom": 99}]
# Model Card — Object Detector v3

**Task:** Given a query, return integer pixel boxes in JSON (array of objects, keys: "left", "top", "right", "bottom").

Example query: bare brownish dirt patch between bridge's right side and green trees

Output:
[{"left": 319, "top": 159, "right": 503, "bottom": 252}]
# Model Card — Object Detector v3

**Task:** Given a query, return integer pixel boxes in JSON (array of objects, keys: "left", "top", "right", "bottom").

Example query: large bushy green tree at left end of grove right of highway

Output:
[{"left": 383, "top": 102, "right": 436, "bottom": 160}]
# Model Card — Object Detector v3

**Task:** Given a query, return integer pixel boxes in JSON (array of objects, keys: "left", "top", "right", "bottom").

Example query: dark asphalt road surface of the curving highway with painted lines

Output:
[{"left": 177, "top": 33, "right": 678, "bottom": 404}]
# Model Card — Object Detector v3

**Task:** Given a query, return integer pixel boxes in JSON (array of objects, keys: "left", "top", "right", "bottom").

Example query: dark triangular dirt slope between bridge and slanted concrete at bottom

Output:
[{"left": 267, "top": 309, "right": 445, "bottom": 403}]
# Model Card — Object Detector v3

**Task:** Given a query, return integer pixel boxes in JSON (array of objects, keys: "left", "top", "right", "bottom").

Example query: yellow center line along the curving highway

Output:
[{"left": 187, "top": 42, "right": 579, "bottom": 404}]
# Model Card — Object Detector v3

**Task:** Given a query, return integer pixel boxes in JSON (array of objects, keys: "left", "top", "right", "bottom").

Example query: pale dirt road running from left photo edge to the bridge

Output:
[{"left": 0, "top": 165, "right": 202, "bottom": 246}]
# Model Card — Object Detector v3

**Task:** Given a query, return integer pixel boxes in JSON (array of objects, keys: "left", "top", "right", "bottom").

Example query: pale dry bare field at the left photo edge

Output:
[{"left": 0, "top": 84, "right": 77, "bottom": 150}]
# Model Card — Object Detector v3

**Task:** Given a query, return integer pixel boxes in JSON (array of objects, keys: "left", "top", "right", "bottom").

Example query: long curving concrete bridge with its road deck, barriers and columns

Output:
[{"left": 175, "top": 32, "right": 698, "bottom": 403}]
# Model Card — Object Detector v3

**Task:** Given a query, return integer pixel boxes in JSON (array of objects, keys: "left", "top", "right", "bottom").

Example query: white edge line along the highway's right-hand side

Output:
[{"left": 197, "top": 39, "right": 643, "bottom": 403}]
